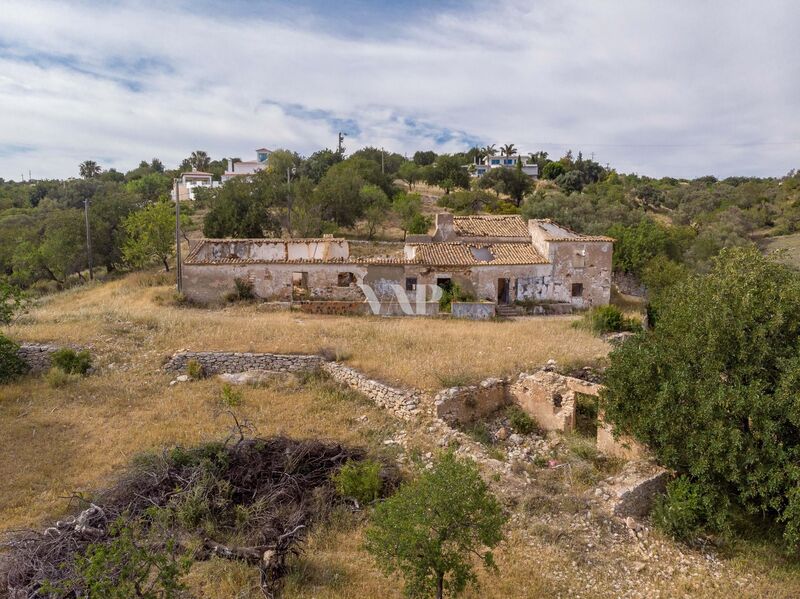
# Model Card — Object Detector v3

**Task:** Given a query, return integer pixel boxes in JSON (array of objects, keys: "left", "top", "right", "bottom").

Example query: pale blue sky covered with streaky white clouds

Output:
[{"left": 0, "top": 0, "right": 800, "bottom": 180}]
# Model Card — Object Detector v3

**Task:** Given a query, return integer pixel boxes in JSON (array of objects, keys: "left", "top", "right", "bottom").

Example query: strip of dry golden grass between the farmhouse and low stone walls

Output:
[{"left": 6, "top": 273, "right": 609, "bottom": 390}]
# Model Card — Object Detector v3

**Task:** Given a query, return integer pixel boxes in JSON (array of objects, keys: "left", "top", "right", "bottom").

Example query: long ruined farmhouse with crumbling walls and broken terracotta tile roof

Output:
[{"left": 183, "top": 214, "right": 613, "bottom": 316}]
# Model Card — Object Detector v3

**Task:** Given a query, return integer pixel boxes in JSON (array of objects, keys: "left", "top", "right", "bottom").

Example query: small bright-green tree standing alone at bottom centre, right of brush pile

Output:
[{"left": 365, "top": 452, "right": 506, "bottom": 599}]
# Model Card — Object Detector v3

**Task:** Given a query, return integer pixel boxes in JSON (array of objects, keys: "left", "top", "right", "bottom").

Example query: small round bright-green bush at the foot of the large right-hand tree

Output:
[{"left": 653, "top": 476, "right": 706, "bottom": 541}]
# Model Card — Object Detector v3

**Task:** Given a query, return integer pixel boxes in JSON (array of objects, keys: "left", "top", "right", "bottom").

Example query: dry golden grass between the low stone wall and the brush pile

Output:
[{"left": 0, "top": 369, "right": 396, "bottom": 529}]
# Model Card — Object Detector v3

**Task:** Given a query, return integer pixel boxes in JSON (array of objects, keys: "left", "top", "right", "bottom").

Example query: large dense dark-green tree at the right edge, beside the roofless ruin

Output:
[{"left": 600, "top": 246, "right": 800, "bottom": 550}]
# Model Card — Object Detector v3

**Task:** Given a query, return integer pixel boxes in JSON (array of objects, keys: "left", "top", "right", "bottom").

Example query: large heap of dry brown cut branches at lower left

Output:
[{"left": 2, "top": 436, "right": 364, "bottom": 598}]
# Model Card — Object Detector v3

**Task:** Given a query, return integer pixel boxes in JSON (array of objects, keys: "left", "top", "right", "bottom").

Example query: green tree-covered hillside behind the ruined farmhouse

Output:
[{"left": 0, "top": 144, "right": 800, "bottom": 298}]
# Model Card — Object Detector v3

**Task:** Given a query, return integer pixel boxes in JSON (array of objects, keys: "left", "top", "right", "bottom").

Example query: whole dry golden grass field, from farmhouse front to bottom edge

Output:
[{"left": 0, "top": 273, "right": 800, "bottom": 599}]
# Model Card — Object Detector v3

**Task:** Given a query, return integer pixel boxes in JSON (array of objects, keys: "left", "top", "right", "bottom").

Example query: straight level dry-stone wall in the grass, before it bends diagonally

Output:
[{"left": 164, "top": 352, "right": 323, "bottom": 374}]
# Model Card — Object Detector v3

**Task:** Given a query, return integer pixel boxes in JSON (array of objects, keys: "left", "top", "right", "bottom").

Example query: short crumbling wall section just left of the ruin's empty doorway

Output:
[{"left": 433, "top": 378, "right": 510, "bottom": 425}]
